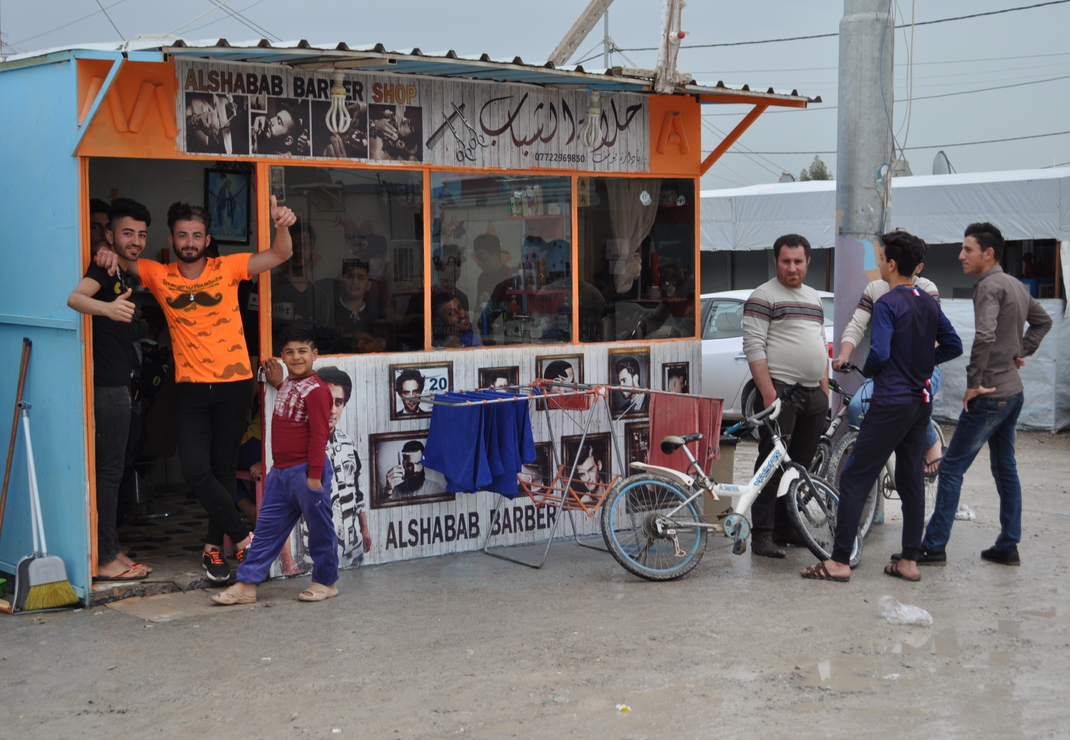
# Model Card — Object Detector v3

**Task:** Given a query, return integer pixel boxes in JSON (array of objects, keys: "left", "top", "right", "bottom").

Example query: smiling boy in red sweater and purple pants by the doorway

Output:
[{"left": 212, "top": 324, "right": 338, "bottom": 605}]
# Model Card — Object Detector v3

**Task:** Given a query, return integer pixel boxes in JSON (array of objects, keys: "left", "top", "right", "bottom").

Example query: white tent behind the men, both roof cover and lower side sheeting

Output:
[{"left": 701, "top": 168, "right": 1070, "bottom": 432}]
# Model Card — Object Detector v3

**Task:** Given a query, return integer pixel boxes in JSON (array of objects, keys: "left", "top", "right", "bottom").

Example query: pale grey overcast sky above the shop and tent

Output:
[{"left": 0, "top": 0, "right": 1070, "bottom": 188}]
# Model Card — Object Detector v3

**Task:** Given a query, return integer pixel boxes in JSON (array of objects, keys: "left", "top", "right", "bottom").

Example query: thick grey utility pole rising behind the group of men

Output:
[{"left": 834, "top": 0, "right": 895, "bottom": 370}]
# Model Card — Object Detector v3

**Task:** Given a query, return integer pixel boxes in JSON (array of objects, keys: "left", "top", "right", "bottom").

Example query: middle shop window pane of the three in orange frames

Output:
[{"left": 430, "top": 173, "right": 582, "bottom": 348}]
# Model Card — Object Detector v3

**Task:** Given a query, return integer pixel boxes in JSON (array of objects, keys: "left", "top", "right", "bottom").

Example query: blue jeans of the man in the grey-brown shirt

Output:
[{"left": 921, "top": 394, "right": 1024, "bottom": 551}]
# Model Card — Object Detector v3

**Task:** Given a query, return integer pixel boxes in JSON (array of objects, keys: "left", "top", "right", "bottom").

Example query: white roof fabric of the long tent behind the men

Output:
[{"left": 701, "top": 167, "right": 1070, "bottom": 251}]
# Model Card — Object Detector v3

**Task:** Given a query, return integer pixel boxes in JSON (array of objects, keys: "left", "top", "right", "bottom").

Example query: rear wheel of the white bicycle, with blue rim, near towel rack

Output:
[{"left": 601, "top": 474, "right": 706, "bottom": 581}]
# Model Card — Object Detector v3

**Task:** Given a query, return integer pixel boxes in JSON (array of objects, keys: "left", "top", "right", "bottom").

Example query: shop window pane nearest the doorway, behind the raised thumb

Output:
[{"left": 271, "top": 166, "right": 424, "bottom": 354}]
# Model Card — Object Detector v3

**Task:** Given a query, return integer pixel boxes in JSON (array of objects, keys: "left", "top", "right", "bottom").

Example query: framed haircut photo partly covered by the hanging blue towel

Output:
[{"left": 368, "top": 430, "right": 457, "bottom": 509}]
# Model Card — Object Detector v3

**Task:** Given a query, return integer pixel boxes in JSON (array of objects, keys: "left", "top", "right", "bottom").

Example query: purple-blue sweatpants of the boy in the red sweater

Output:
[{"left": 236, "top": 460, "right": 338, "bottom": 586}]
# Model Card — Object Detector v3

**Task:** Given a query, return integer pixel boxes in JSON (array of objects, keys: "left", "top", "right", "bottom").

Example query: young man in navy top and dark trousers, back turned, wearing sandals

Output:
[{"left": 801, "top": 231, "right": 962, "bottom": 583}]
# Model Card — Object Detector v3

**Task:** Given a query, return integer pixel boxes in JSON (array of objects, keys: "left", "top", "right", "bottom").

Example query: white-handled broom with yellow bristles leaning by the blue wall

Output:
[{"left": 15, "top": 401, "right": 81, "bottom": 612}]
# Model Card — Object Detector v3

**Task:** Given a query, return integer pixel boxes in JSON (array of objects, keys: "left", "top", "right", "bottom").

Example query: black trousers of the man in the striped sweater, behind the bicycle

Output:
[{"left": 750, "top": 380, "right": 828, "bottom": 539}]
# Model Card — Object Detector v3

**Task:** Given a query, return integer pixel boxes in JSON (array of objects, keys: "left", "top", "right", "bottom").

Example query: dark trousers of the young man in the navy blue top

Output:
[{"left": 832, "top": 402, "right": 933, "bottom": 565}]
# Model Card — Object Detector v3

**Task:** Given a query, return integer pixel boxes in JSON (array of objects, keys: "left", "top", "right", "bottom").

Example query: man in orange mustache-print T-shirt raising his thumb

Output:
[{"left": 96, "top": 196, "right": 297, "bottom": 582}]
